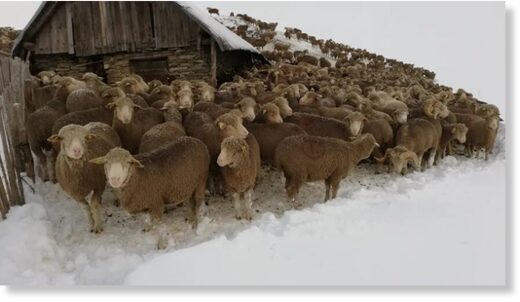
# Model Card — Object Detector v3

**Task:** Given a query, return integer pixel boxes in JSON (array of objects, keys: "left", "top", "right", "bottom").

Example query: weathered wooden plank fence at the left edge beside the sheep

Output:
[{"left": 0, "top": 56, "right": 34, "bottom": 219}]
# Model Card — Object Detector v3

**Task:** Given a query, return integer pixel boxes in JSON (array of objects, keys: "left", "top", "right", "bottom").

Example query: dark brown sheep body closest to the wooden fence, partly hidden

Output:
[{"left": 25, "top": 100, "right": 66, "bottom": 181}]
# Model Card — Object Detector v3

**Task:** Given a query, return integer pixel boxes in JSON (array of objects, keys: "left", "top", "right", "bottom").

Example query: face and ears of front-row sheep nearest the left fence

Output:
[{"left": 48, "top": 124, "right": 95, "bottom": 159}]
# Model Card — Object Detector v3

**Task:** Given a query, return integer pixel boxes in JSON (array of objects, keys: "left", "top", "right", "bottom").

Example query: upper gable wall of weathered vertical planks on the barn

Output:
[{"left": 33, "top": 1, "right": 199, "bottom": 57}]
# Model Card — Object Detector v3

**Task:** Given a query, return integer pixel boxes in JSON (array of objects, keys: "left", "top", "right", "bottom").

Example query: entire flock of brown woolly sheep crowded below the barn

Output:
[{"left": 26, "top": 11, "right": 500, "bottom": 248}]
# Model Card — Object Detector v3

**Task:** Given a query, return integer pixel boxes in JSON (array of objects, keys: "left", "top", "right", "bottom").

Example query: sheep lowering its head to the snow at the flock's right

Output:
[{"left": 375, "top": 118, "right": 441, "bottom": 174}]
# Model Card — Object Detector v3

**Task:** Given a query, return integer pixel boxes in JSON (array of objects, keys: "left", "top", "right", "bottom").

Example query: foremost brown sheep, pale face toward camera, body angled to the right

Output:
[{"left": 90, "top": 136, "right": 209, "bottom": 243}]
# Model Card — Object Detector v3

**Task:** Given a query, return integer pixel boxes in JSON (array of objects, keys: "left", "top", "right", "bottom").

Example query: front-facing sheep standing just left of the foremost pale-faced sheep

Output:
[{"left": 49, "top": 123, "right": 120, "bottom": 233}]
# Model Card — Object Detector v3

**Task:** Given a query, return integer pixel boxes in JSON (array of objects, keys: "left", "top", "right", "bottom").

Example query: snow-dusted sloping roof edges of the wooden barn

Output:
[{"left": 12, "top": 1, "right": 262, "bottom": 56}]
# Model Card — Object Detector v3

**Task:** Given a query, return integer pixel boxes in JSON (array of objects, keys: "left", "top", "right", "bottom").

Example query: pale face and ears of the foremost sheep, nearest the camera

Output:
[{"left": 90, "top": 147, "right": 143, "bottom": 189}]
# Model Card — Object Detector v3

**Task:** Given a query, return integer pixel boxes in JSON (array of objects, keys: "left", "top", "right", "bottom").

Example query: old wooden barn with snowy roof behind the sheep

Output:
[{"left": 12, "top": 1, "right": 268, "bottom": 84}]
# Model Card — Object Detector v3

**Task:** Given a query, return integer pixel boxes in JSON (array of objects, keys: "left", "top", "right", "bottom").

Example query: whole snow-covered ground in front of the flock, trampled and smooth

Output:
[{"left": 0, "top": 125, "right": 506, "bottom": 285}]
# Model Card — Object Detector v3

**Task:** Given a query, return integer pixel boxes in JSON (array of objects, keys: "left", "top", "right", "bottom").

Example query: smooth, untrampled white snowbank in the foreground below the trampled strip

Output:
[{"left": 125, "top": 151, "right": 506, "bottom": 285}]
